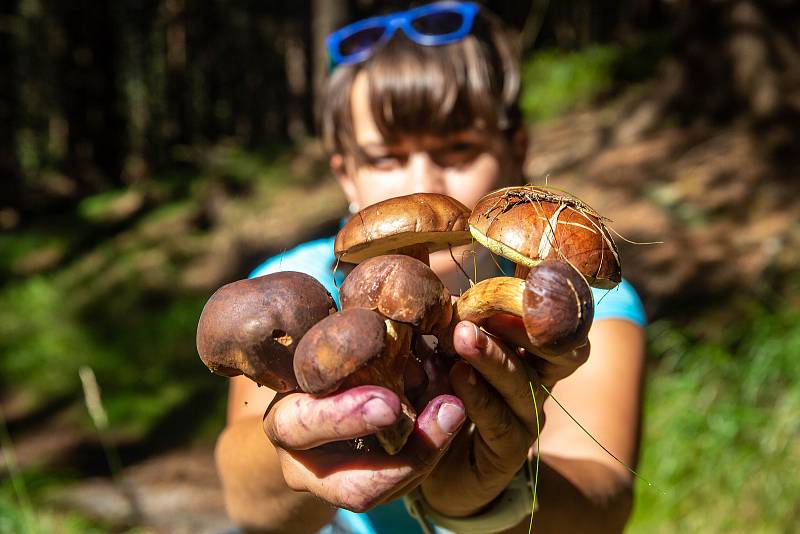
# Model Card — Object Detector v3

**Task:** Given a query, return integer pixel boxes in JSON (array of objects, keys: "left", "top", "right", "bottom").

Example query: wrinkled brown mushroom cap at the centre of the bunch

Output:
[{"left": 339, "top": 254, "right": 452, "bottom": 334}]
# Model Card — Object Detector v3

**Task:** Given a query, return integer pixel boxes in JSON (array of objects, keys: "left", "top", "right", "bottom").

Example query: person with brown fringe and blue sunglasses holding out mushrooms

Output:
[{"left": 217, "top": 2, "right": 644, "bottom": 532}]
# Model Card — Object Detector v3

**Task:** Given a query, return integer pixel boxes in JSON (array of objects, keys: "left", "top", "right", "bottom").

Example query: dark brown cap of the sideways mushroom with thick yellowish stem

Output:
[{"left": 522, "top": 260, "right": 594, "bottom": 355}]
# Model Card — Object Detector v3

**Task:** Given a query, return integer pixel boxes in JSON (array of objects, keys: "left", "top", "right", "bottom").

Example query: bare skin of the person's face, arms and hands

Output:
[{"left": 217, "top": 59, "right": 643, "bottom": 532}]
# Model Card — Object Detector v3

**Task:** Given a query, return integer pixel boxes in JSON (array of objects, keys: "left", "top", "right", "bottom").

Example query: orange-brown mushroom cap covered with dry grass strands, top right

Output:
[{"left": 469, "top": 186, "right": 622, "bottom": 289}]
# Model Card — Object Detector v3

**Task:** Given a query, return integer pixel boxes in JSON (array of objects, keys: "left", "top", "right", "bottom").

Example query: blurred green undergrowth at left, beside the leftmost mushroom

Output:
[{"left": 0, "top": 276, "right": 224, "bottom": 436}]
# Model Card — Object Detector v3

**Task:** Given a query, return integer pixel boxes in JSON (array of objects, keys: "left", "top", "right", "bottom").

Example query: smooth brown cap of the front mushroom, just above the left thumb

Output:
[{"left": 294, "top": 308, "right": 386, "bottom": 395}]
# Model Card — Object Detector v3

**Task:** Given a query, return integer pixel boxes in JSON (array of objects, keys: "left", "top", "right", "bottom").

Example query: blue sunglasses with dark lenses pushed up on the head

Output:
[{"left": 326, "top": 2, "right": 479, "bottom": 67}]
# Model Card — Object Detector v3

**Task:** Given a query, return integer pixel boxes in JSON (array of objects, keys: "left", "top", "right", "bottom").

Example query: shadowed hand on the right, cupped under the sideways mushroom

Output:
[{"left": 422, "top": 318, "right": 589, "bottom": 517}]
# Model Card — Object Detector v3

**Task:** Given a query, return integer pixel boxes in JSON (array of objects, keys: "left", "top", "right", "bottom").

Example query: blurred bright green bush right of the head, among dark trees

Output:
[{"left": 520, "top": 45, "right": 622, "bottom": 122}]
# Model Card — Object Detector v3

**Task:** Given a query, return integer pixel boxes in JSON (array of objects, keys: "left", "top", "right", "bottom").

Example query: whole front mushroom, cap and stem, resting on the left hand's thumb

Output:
[{"left": 294, "top": 308, "right": 416, "bottom": 454}]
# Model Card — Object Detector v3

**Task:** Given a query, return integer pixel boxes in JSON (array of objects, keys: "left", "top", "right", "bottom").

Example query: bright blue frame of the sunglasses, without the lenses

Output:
[{"left": 325, "top": 1, "right": 480, "bottom": 67}]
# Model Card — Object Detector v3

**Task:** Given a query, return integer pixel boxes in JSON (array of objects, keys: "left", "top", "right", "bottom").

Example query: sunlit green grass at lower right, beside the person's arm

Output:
[{"left": 629, "top": 304, "right": 800, "bottom": 533}]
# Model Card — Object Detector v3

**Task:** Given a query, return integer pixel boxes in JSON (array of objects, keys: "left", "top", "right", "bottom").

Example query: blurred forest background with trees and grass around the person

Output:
[{"left": 0, "top": 0, "right": 800, "bottom": 533}]
